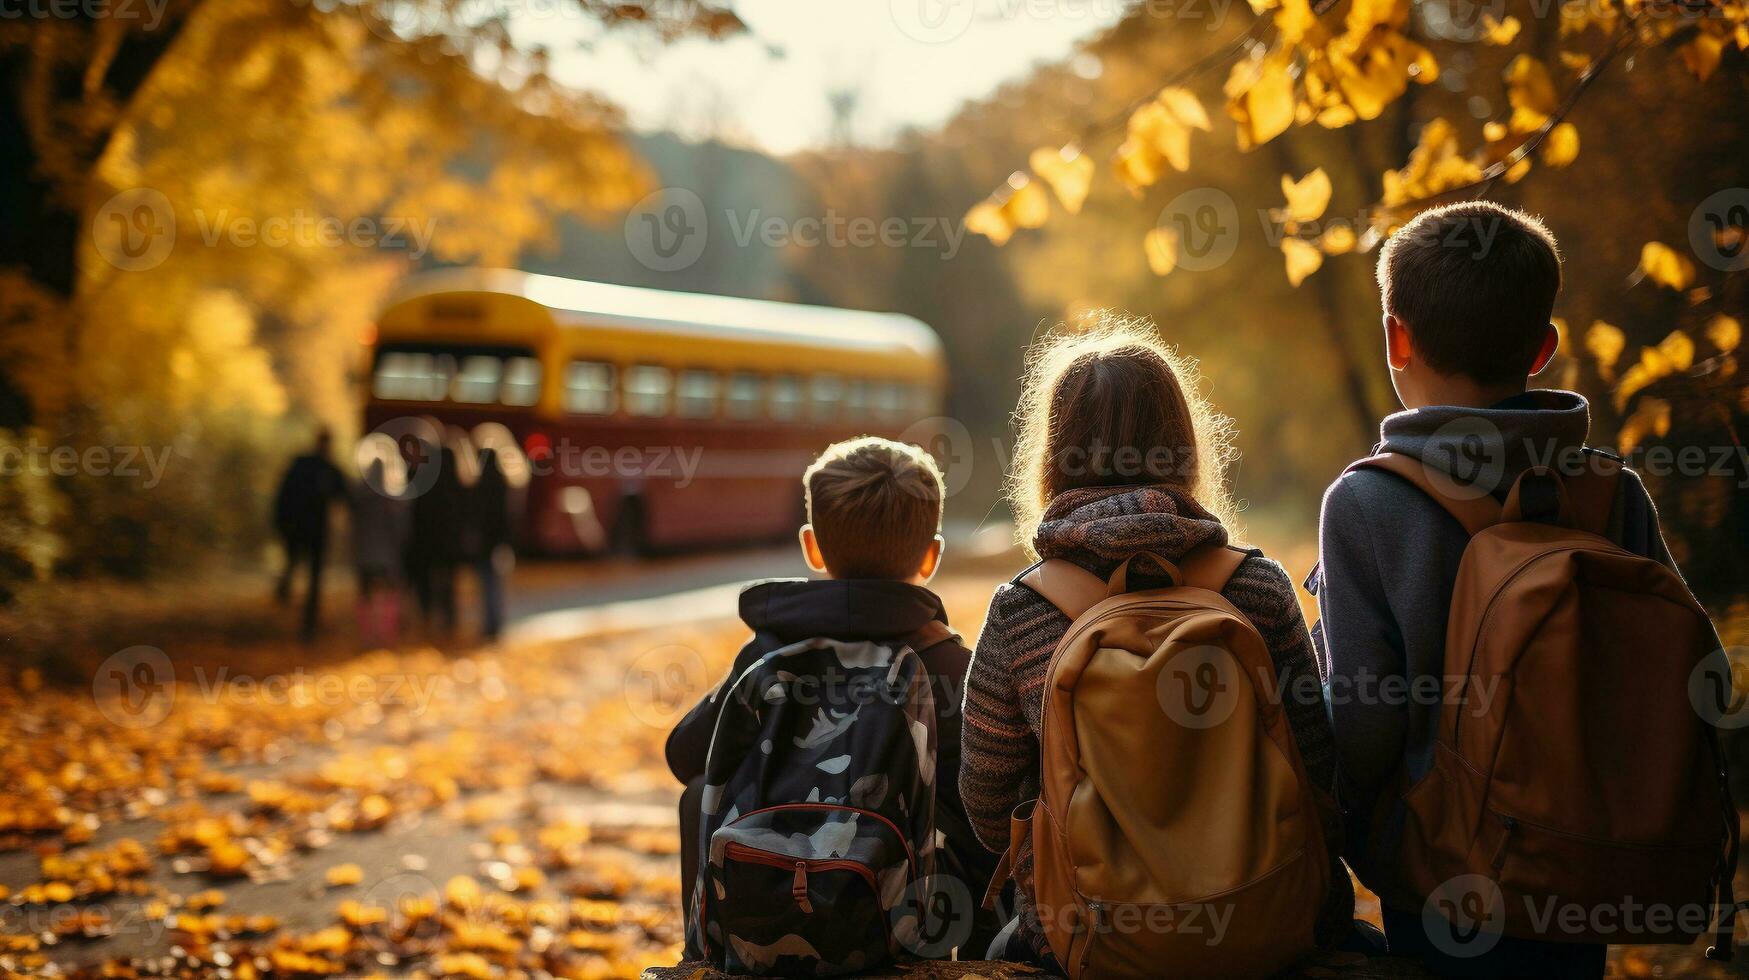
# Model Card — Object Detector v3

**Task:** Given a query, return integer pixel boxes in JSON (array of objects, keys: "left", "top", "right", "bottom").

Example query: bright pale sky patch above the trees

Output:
[{"left": 512, "top": 0, "right": 1125, "bottom": 154}]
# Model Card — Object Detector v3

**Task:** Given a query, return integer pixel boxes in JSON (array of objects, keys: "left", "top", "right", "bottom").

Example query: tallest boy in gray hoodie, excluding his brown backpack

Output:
[{"left": 1307, "top": 201, "right": 1674, "bottom": 977}]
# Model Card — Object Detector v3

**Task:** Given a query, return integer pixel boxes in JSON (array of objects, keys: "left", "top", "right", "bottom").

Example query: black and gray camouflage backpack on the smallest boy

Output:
[{"left": 687, "top": 623, "right": 948, "bottom": 977}]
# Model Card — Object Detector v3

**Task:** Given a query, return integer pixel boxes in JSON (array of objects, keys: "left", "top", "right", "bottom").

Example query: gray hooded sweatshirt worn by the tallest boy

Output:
[{"left": 1307, "top": 390, "right": 1676, "bottom": 910}]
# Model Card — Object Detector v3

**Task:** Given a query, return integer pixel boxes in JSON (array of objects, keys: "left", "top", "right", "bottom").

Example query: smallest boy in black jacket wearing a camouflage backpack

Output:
[{"left": 666, "top": 438, "right": 997, "bottom": 975}]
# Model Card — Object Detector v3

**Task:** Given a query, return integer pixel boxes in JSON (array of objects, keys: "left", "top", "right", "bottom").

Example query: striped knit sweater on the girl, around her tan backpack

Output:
[{"left": 960, "top": 487, "right": 1354, "bottom": 952}]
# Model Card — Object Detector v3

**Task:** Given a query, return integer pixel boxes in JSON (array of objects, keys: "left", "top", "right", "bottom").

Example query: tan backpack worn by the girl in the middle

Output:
[{"left": 1009, "top": 548, "right": 1329, "bottom": 978}]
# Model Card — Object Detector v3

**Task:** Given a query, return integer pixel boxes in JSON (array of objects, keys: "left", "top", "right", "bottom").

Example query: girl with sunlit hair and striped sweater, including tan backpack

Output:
[{"left": 960, "top": 315, "right": 1354, "bottom": 977}]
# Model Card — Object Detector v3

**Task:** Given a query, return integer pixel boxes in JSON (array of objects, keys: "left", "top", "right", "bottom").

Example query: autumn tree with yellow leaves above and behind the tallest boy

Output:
[{"left": 965, "top": 0, "right": 1749, "bottom": 612}]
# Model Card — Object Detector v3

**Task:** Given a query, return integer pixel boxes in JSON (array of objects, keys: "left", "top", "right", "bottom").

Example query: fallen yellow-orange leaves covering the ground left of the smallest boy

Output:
[{"left": 0, "top": 619, "right": 752, "bottom": 978}]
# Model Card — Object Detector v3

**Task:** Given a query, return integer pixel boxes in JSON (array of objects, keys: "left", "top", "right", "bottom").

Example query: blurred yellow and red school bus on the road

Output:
[{"left": 364, "top": 268, "right": 946, "bottom": 553}]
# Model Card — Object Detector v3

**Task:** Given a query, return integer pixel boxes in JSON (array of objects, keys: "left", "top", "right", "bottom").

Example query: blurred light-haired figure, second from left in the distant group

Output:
[{"left": 352, "top": 459, "right": 413, "bottom": 649}]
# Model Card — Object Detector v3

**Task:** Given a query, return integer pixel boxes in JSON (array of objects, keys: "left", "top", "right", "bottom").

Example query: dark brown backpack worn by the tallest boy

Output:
[{"left": 1350, "top": 453, "right": 1737, "bottom": 959}]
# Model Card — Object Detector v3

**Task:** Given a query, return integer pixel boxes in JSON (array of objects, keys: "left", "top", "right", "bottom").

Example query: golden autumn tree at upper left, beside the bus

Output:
[{"left": 0, "top": 0, "right": 740, "bottom": 588}]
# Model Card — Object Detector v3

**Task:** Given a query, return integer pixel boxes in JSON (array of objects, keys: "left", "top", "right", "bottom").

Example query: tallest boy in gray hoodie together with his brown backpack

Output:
[{"left": 1307, "top": 203, "right": 1737, "bottom": 977}]
